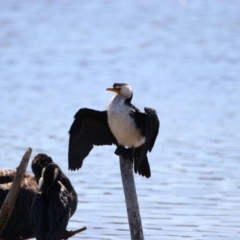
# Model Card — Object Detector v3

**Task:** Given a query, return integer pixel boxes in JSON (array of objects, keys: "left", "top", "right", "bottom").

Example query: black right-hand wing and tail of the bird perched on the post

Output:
[{"left": 134, "top": 107, "right": 160, "bottom": 177}]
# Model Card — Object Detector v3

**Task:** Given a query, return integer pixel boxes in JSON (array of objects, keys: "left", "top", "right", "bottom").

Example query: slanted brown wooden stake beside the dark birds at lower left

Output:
[{"left": 0, "top": 148, "right": 32, "bottom": 236}]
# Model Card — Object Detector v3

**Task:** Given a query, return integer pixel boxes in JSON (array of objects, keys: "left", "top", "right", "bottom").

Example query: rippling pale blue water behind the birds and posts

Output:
[{"left": 0, "top": 0, "right": 240, "bottom": 240}]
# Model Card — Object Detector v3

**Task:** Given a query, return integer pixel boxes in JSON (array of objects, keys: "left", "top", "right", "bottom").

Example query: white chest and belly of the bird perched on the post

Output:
[{"left": 107, "top": 97, "right": 145, "bottom": 147}]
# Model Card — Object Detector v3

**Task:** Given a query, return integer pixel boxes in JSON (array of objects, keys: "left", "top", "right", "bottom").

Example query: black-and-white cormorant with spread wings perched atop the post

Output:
[{"left": 68, "top": 83, "right": 160, "bottom": 178}]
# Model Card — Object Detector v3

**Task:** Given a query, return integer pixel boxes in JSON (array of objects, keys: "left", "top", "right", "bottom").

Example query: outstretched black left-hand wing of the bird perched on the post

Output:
[{"left": 68, "top": 108, "right": 117, "bottom": 170}]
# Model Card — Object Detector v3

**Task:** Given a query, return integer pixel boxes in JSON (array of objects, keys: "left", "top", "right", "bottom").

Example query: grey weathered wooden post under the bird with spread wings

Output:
[{"left": 119, "top": 156, "right": 144, "bottom": 240}]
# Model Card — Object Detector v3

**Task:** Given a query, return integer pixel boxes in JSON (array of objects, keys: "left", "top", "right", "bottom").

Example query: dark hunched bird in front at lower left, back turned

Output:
[{"left": 30, "top": 155, "right": 77, "bottom": 240}]
